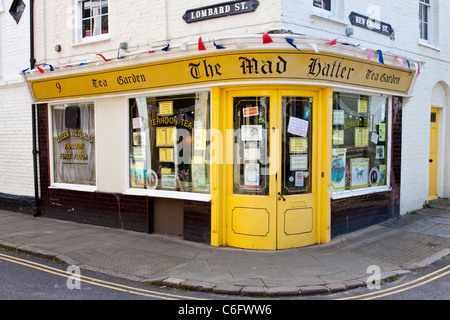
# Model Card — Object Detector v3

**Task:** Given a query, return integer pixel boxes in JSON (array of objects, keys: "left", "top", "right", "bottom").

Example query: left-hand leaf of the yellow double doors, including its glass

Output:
[{"left": 227, "top": 90, "right": 277, "bottom": 250}]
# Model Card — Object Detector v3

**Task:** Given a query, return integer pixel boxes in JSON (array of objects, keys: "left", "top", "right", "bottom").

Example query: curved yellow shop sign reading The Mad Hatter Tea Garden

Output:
[{"left": 29, "top": 50, "right": 415, "bottom": 102}]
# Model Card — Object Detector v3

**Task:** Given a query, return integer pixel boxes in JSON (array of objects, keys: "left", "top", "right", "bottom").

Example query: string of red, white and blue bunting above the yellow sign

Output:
[{"left": 22, "top": 32, "right": 421, "bottom": 77}]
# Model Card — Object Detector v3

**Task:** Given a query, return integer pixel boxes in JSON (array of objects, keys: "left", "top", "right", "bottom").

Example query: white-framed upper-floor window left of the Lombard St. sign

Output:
[{"left": 79, "top": 0, "right": 109, "bottom": 39}]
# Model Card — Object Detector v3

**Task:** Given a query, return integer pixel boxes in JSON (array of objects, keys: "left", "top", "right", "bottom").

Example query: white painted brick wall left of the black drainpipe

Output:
[{"left": 0, "top": 0, "right": 34, "bottom": 196}]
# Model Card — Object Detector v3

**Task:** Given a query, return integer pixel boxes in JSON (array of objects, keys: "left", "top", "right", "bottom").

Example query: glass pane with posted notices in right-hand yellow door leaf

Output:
[{"left": 281, "top": 97, "right": 313, "bottom": 195}]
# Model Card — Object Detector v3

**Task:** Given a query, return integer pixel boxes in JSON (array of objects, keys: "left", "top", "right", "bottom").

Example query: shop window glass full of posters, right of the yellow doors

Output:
[{"left": 331, "top": 93, "right": 389, "bottom": 193}]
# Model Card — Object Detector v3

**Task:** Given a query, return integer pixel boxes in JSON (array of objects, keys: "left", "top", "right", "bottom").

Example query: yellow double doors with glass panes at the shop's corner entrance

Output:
[{"left": 226, "top": 90, "right": 317, "bottom": 250}]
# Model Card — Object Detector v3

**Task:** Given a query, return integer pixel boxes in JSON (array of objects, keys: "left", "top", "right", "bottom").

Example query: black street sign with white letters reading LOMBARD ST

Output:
[{"left": 183, "top": 0, "right": 259, "bottom": 23}]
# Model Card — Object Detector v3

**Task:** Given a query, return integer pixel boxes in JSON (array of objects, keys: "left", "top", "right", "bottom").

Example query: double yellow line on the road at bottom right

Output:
[{"left": 337, "top": 265, "right": 450, "bottom": 300}]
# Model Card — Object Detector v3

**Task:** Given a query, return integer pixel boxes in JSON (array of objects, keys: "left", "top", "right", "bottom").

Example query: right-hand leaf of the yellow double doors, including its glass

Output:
[{"left": 277, "top": 91, "right": 317, "bottom": 249}]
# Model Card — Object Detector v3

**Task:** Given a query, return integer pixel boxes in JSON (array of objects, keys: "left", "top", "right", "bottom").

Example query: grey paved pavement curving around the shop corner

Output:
[{"left": 0, "top": 199, "right": 450, "bottom": 296}]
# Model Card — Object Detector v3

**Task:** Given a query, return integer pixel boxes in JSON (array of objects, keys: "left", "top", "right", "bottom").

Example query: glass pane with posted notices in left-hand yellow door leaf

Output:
[{"left": 233, "top": 97, "right": 270, "bottom": 195}]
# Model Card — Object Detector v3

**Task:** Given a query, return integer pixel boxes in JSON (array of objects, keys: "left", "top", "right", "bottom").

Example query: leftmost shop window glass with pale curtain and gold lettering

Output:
[{"left": 51, "top": 104, "right": 95, "bottom": 186}]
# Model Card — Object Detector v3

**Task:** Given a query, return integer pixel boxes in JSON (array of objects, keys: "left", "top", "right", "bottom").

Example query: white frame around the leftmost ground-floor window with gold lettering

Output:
[{"left": 47, "top": 101, "right": 98, "bottom": 192}]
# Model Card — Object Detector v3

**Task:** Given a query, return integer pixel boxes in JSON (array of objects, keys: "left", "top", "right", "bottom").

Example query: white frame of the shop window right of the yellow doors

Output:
[{"left": 331, "top": 89, "right": 393, "bottom": 200}]
